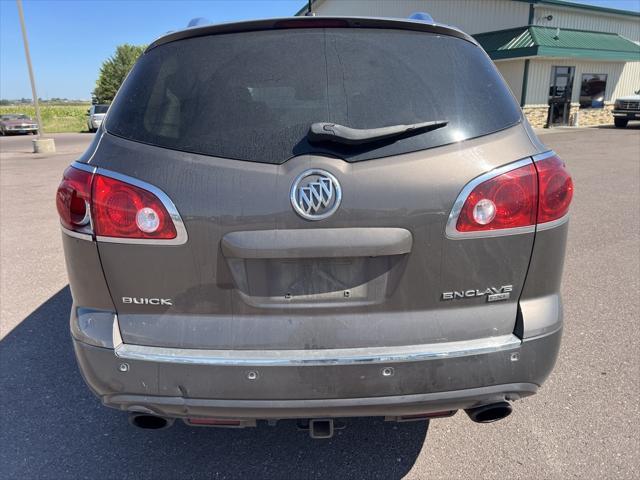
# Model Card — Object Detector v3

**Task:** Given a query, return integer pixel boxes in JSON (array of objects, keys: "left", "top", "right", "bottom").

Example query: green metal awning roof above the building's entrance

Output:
[{"left": 474, "top": 25, "right": 640, "bottom": 61}]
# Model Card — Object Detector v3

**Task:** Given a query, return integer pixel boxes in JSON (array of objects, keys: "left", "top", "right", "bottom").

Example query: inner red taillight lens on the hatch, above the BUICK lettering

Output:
[{"left": 92, "top": 174, "right": 177, "bottom": 240}]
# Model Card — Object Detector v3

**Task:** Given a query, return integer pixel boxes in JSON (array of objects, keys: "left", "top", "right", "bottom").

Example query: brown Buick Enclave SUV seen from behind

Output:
[{"left": 57, "top": 17, "right": 573, "bottom": 438}]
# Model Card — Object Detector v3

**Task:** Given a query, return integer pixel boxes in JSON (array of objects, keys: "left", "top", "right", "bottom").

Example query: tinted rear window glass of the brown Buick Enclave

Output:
[{"left": 107, "top": 28, "right": 520, "bottom": 164}]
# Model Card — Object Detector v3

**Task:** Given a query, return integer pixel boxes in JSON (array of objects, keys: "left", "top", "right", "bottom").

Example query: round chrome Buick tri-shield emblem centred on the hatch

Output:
[{"left": 291, "top": 168, "right": 342, "bottom": 220}]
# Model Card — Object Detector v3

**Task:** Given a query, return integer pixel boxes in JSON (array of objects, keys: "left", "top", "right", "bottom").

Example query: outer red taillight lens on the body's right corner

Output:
[{"left": 535, "top": 155, "right": 573, "bottom": 223}]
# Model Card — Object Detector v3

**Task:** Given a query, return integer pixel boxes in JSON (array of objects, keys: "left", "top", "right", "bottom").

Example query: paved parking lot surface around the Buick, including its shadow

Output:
[{"left": 0, "top": 127, "right": 640, "bottom": 479}]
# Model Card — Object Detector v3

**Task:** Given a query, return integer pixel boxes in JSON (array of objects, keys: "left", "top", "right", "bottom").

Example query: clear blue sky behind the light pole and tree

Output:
[{"left": 0, "top": 0, "right": 640, "bottom": 99}]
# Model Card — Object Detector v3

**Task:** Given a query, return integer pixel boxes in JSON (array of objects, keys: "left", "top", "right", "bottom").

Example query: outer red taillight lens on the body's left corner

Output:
[{"left": 56, "top": 167, "right": 92, "bottom": 230}]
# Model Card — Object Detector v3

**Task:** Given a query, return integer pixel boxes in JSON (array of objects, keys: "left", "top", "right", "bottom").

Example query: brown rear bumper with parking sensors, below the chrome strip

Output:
[{"left": 74, "top": 329, "right": 561, "bottom": 419}]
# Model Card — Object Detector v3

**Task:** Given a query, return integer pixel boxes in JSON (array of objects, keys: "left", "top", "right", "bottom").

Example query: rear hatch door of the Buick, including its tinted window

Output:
[{"left": 91, "top": 24, "right": 536, "bottom": 349}]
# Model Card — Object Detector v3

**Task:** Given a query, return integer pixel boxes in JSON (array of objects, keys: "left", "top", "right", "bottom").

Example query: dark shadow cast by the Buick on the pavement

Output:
[{"left": 0, "top": 287, "right": 427, "bottom": 479}]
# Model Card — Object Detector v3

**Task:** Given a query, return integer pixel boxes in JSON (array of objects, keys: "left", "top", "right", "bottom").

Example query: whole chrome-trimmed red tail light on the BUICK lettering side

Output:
[{"left": 56, "top": 166, "right": 186, "bottom": 243}]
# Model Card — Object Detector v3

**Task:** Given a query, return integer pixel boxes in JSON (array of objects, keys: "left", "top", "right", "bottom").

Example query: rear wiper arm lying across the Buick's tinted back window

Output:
[{"left": 307, "top": 120, "right": 449, "bottom": 145}]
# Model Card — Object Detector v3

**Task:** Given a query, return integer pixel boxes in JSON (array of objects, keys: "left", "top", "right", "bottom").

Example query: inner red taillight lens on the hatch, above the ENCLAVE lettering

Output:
[{"left": 456, "top": 164, "right": 538, "bottom": 232}]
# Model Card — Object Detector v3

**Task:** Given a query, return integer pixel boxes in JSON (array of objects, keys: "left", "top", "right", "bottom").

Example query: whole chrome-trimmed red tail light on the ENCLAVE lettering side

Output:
[{"left": 447, "top": 154, "right": 573, "bottom": 238}]
